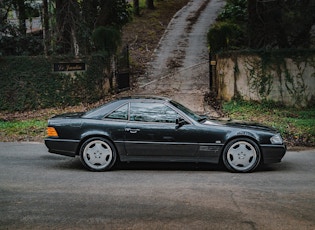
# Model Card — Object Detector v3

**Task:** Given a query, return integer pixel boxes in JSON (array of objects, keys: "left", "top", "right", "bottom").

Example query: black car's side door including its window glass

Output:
[{"left": 125, "top": 102, "right": 198, "bottom": 158}]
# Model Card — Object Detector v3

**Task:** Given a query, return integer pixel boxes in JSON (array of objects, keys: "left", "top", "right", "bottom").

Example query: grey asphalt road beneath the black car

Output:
[{"left": 0, "top": 143, "right": 315, "bottom": 229}]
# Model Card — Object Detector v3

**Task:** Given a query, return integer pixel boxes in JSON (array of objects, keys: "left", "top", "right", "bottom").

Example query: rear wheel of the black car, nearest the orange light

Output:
[{"left": 80, "top": 137, "right": 117, "bottom": 172}]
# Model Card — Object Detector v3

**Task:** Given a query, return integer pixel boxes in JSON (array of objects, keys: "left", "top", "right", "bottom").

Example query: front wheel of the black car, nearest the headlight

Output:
[{"left": 222, "top": 138, "right": 261, "bottom": 172}]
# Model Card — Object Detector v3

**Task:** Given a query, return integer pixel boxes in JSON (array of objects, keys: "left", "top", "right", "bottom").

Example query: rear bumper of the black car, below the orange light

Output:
[{"left": 45, "top": 138, "right": 79, "bottom": 157}]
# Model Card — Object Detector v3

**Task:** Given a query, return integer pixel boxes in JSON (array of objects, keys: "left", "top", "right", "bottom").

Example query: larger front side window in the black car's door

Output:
[{"left": 130, "top": 102, "right": 179, "bottom": 123}]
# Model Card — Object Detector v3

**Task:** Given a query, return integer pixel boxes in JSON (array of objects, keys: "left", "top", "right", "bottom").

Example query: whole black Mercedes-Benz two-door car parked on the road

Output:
[{"left": 45, "top": 97, "right": 286, "bottom": 172}]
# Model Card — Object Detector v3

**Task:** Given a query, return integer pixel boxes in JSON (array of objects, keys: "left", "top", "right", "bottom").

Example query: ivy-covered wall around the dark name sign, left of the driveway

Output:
[{"left": 0, "top": 55, "right": 111, "bottom": 111}]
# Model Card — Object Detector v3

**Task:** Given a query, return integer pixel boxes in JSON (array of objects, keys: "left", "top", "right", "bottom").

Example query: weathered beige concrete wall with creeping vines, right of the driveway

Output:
[{"left": 214, "top": 51, "right": 315, "bottom": 107}]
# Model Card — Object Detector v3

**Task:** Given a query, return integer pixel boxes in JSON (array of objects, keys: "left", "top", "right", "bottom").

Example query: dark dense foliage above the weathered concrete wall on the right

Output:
[{"left": 210, "top": 0, "right": 315, "bottom": 50}]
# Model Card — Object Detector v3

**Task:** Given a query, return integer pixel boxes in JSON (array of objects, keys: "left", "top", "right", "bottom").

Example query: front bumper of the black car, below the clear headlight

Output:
[{"left": 261, "top": 144, "right": 287, "bottom": 164}]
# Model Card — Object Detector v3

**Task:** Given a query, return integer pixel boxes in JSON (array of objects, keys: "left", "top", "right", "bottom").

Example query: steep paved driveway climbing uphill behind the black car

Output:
[{"left": 135, "top": 0, "right": 226, "bottom": 116}]
